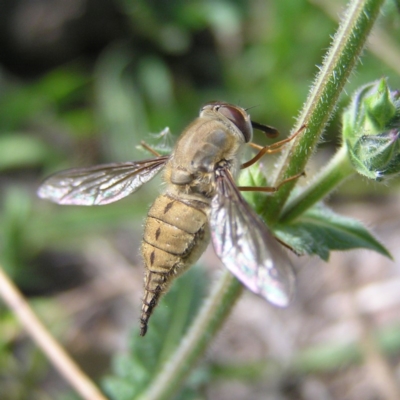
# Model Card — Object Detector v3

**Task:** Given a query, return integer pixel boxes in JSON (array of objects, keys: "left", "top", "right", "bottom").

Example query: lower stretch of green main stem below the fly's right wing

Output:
[{"left": 139, "top": 270, "right": 243, "bottom": 400}]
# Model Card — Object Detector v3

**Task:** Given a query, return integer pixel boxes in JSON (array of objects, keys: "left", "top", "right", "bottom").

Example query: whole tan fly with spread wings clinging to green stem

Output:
[{"left": 38, "top": 102, "right": 300, "bottom": 336}]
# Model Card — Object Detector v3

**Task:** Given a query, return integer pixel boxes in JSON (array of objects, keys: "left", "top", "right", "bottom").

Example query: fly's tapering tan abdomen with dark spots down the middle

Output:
[{"left": 141, "top": 194, "right": 209, "bottom": 336}]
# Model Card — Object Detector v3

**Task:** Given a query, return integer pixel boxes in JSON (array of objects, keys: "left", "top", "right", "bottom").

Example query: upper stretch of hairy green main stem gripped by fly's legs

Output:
[{"left": 263, "top": 0, "right": 383, "bottom": 225}]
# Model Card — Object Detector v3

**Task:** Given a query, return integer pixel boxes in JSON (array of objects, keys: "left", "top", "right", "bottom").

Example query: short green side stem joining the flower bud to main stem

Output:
[{"left": 280, "top": 146, "right": 355, "bottom": 222}]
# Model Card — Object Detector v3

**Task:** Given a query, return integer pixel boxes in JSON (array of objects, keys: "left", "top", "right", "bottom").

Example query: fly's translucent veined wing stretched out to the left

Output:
[{"left": 38, "top": 156, "right": 169, "bottom": 206}]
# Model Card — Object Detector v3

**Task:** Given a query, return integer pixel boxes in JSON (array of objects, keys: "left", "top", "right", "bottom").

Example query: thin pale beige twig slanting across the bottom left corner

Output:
[{"left": 0, "top": 266, "right": 106, "bottom": 400}]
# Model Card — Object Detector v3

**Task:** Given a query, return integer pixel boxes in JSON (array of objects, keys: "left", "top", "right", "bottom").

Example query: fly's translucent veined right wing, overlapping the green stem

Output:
[{"left": 210, "top": 168, "right": 294, "bottom": 307}]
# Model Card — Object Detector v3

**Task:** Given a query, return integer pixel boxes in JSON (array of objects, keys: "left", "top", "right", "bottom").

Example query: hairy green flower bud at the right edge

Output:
[{"left": 343, "top": 79, "right": 400, "bottom": 181}]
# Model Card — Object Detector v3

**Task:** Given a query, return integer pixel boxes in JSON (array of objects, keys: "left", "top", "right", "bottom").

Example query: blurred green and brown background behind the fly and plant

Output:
[{"left": 0, "top": 0, "right": 400, "bottom": 400}]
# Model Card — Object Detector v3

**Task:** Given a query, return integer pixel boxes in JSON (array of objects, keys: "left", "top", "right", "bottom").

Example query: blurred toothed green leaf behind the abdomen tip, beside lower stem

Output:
[{"left": 103, "top": 267, "right": 206, "bottom": 400}]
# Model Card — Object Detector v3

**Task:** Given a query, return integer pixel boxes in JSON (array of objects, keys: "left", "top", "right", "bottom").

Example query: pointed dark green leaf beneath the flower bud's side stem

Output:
[{"left": 274, "top": 204, "right": 392, "bottom": 261}]
